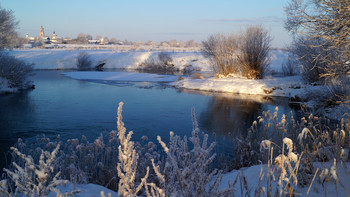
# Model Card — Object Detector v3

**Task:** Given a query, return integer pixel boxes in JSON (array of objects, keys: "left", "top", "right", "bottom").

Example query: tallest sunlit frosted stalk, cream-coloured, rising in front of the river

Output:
[{"left": 117, "top": 102, "right": 149, "bottom": 196}]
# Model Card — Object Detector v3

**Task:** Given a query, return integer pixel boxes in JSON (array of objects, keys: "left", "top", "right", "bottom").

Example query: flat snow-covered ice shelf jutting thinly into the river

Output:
[{"left": 64, "top": 71, "right": 178, "bottom": 82}]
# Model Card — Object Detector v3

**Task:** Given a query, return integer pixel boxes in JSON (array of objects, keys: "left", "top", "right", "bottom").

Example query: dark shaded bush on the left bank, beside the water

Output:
[{"left": 0, "top": 51, "right": 33, "bottom": 89}]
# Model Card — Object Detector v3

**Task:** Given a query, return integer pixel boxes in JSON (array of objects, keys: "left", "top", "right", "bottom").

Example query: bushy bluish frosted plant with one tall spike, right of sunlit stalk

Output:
[{"left": 155, "top": 109, "right": 233, "bottom": 196}]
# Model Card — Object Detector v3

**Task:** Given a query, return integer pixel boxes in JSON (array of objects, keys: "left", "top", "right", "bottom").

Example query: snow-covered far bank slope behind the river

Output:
[{"left": 10, "top": 48, "right": 287, "bottom": 72}]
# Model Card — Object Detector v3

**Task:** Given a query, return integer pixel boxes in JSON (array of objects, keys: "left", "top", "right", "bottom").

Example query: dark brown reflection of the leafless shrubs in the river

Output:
[{"left": 200, "top": 96, "right": 262, "bottom": 137}]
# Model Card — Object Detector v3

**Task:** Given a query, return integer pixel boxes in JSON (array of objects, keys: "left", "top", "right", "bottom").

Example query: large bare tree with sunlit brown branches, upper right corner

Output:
[{"left": 285, "top": 0, "right": 350, "bottom": 78}]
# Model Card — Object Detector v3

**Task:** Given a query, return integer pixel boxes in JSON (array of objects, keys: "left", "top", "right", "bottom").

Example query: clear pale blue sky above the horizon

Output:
[{"left": 0, "top": 0, "right": 291, "bottom": 47}]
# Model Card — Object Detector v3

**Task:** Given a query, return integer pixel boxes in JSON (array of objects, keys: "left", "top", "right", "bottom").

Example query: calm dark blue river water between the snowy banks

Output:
[{"left": 0, "top": 70, "right": 293, "bottom": 170}]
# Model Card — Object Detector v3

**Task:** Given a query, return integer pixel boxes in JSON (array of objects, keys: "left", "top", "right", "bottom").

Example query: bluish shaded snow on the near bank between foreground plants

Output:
[{"left": 47, "top": 161, "right": 350, "bottom": 197}]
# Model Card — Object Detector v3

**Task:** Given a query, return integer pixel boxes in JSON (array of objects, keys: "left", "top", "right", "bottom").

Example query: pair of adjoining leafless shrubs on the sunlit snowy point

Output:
[{"left": 202, "top": 26, "right": 271, "bottom": 79}]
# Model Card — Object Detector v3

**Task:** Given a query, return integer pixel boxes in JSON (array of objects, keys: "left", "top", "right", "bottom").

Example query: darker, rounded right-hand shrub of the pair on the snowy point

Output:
[{"left": 238, "top": 26, "right": 271, "bottom": 79}]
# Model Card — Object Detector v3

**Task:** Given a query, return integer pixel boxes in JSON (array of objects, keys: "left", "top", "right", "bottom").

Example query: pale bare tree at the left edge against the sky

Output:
[{"left": 0, "top": 5, "right": 18, "bottom": 50}]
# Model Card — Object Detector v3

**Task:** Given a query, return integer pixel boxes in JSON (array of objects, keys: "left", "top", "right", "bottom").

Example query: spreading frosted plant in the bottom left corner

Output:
[{"left": 4, "top": 144, "right": 76, "bottom": 196}]
